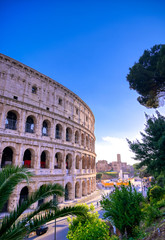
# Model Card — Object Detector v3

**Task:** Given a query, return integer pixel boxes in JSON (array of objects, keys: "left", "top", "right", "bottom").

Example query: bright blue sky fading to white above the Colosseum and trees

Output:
[{"left": 0, "top": 0, "right": 165, "bottom": 164}]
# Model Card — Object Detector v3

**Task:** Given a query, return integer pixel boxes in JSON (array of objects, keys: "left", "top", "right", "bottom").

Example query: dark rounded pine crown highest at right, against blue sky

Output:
[{"left": 127, "top": 44, "right": 165, "bottom": 108}]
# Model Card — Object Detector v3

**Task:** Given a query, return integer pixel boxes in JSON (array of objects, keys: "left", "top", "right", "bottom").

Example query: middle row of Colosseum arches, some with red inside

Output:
[{"left": 1, "top": 146, "right": 95, "bottom": 169}]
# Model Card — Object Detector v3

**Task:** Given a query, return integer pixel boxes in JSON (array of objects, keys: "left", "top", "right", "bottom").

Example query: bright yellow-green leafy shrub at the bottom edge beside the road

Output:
[{"left": 67, "top": 205, "right": 111, "bottom": 240}]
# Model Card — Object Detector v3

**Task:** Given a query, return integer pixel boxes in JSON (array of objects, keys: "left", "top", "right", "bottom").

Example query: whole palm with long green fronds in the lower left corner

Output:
[{"left": 0, "top": 166, "right": 86, "bottom": 240}]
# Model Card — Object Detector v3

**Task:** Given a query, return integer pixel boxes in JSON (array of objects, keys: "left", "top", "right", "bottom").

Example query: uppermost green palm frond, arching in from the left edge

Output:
[{"left": 0, "top": 166, "right": 32, "bottom": 210}]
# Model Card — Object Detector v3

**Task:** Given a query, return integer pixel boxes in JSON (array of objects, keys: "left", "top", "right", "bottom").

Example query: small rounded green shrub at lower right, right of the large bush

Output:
[{"left": 143, "top": 204, "right": 161, "bottom": 227}]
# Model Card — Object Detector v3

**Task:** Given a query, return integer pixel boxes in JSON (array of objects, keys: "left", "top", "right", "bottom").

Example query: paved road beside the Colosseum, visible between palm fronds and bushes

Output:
[{"left": 28, "top": 190, "right": 111, "bottom": 240}]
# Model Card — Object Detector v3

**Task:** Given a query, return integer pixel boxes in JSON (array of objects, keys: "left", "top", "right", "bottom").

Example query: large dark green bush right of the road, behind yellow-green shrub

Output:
[{"left": 101, "top": 184, "right": 143, "bottom": 237}]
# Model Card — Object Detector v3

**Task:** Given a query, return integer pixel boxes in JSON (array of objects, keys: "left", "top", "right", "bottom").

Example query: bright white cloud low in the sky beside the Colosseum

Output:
[{"left": 96, "top": 136, "right": 140, "bottom": 165}]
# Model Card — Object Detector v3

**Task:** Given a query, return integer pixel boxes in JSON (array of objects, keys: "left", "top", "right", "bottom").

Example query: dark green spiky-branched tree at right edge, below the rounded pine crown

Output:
[{"left": 127, "top": 111, "right": 165, "bottom": 177}]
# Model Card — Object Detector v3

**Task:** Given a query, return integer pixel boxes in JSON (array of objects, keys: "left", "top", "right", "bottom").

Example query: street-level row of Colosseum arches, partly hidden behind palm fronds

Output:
[{"left": 2, "top": 178, "right": 96, "bottom": 212}]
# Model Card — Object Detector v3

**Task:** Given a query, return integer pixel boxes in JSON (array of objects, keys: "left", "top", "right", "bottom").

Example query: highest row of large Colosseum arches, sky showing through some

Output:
[{"left": 5, "top": 110, "right": 95, "bottom": 149}]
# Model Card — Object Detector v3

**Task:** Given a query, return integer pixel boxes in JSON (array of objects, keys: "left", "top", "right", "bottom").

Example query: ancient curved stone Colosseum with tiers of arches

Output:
[{"left": 0, "top": 54, "right": 96, "bottom": 212}]
